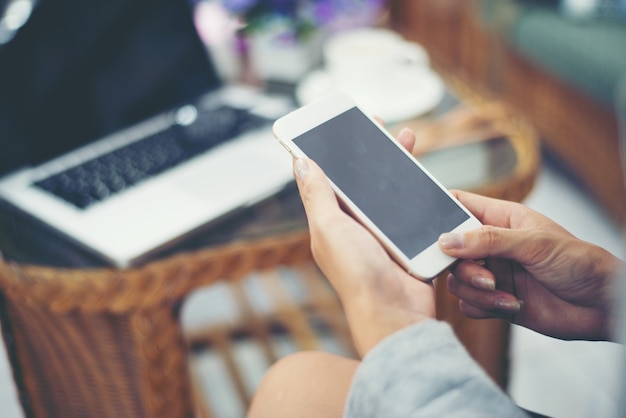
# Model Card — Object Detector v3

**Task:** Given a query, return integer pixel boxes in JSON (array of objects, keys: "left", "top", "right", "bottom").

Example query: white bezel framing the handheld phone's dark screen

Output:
[{"left": 273, "top": 94, "right": 481, "bottom": 281}]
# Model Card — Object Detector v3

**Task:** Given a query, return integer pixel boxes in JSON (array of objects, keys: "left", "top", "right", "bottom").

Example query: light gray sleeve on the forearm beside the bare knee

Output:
[{"left": 344, "top": 320, "right": 528, "bottom": 418}]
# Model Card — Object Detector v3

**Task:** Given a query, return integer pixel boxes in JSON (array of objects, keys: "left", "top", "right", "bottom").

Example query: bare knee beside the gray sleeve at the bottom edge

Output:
[{"left": 249, "top": 351, "right": 358, "bottom": 418}]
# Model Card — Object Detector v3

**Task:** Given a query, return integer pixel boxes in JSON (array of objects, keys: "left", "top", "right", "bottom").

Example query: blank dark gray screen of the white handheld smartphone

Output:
[{"left": 293, "top": 107, "right": 469, "bottom": 258}]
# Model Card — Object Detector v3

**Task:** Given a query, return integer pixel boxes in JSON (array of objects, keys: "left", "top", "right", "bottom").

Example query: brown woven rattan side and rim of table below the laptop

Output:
[{"left": 0, "top": 232, "right": 311, "bottom": 418}]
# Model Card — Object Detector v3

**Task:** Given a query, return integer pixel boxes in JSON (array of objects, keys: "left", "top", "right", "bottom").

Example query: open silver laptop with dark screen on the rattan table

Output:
[{"left": 0, "top": 0, "right": 293, "bottom": 267}]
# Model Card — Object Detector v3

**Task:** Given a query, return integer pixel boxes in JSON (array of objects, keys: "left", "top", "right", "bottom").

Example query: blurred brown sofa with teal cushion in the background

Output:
[{"left": 390, "top": 0, "right": 626, "bottom": 225}]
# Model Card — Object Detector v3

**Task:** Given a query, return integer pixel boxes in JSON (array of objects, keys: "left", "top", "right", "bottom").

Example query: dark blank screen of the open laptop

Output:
[{"left": 0, "top": 0, "right": 220, "bottom": 175}]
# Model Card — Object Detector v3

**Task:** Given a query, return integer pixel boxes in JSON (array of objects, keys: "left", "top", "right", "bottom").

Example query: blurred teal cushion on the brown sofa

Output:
[{"left": 481, "top": 0, "right": 626, "bottom": 106}]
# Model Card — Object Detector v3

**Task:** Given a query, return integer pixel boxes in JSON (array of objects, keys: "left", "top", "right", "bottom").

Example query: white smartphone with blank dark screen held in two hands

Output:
[{"left": 273, "top": 94, "right": 480, "bottom": 281}]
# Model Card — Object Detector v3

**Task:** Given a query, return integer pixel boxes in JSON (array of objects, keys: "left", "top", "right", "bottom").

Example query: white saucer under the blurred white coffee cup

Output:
[{"left": 295, "top": 67, "right": 445, "bottom": 123}]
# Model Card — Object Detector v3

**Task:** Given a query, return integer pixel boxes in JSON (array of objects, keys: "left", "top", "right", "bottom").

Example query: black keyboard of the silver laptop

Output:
[{"left": 35, "top": 106, "right": 270, "bottom": 209}]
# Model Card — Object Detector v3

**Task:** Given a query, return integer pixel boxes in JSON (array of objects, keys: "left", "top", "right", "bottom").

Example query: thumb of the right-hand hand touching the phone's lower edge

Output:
[{"left": 438, "top": 225, "right": 535, "bottom": 263}]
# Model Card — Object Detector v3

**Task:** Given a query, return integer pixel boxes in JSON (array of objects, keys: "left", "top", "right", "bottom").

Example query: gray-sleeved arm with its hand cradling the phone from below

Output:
[{"left": 294, "top": 129, "right": 524, "bottom": 417}]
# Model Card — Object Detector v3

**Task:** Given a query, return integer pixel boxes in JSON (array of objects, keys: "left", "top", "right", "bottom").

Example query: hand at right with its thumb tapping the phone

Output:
[{"left": 439, "top": 192, "right": 622, "bottom": 340}]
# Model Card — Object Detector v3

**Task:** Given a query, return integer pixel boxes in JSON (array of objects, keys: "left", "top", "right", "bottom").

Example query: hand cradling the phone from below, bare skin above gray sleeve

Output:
[{"left": 294, "top": 131, "right": 435, "bottom": 356}]
